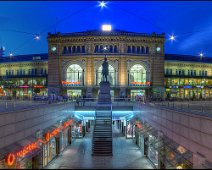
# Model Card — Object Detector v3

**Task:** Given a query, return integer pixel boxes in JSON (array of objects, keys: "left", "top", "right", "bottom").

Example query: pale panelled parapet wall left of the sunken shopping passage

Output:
[{"left": 0, "top": 103, "right": 74, "bottom": 149}]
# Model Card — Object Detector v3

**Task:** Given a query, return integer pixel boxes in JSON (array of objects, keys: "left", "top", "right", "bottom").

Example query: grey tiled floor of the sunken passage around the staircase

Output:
[{"left": 45, "top": 125, "right": 153, "bottom": 169}]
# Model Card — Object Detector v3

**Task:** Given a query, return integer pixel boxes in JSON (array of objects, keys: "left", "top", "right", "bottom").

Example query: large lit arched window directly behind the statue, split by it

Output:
[{"left": 96, "top": 64, "right": 116, "bottom": 85}]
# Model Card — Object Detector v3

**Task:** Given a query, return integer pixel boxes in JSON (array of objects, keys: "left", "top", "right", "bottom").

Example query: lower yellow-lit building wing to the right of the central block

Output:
[{"left": 164, "top": 54, "right": 212, "bottom": 100}]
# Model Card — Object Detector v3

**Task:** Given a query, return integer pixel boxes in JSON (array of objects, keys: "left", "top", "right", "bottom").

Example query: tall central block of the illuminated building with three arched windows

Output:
[{"left": 48, "top": 30, "right": 165, "bottom": 99}]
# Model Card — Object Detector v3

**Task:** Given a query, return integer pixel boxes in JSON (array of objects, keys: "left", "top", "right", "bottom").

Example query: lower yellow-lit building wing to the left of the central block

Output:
[{"left": 0, "top": 54, "right": 48, "bottom": 99}]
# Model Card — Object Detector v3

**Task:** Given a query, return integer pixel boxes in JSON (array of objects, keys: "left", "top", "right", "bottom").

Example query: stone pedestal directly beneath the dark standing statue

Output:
[{"left": 98, "top": 82, "right": 111, "bottom": 104}]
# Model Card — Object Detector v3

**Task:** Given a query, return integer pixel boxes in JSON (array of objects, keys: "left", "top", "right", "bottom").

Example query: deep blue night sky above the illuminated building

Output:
[{"left": 0, "top": 1, "right": 212, "bottom": 57}]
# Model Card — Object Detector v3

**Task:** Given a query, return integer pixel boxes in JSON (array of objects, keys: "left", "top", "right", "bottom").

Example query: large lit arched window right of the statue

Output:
[{"left": 129, "top": 64, "right": 146, "bottom": 84}]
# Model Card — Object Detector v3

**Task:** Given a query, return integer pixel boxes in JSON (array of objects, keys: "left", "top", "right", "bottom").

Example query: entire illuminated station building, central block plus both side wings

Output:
[{"left": 0, "top": 30, "right": 212, "bottom": 100}]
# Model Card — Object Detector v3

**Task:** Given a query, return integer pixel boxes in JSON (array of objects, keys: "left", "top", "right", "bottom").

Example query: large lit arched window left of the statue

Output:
[{"left": 66, "top": 64, "right": 83, "bottom": 85}]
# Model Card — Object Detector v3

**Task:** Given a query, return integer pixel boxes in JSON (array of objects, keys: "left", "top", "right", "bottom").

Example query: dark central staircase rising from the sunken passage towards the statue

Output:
[{"left": 92, "top": 81, "right": 113, "bottom": 156}]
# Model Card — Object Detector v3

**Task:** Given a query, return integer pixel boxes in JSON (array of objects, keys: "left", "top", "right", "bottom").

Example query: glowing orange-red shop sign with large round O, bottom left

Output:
[{"left": 5, "top": 142, "right": 39, "bottom": 166}]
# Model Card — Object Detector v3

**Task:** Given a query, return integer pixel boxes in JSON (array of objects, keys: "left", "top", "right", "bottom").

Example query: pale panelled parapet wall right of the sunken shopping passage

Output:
[{"left": 134, "top": 104, "right": 212, "bottom": 168}]
